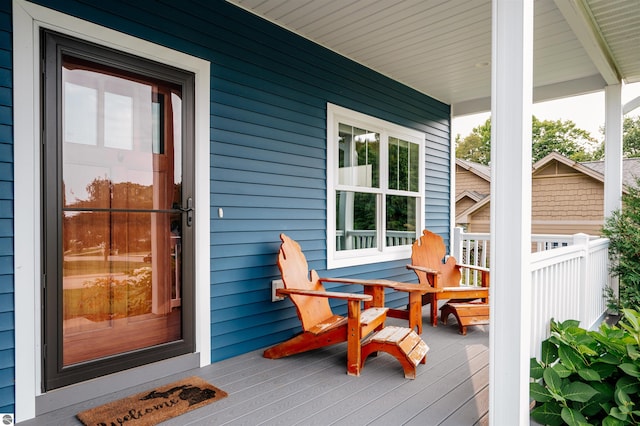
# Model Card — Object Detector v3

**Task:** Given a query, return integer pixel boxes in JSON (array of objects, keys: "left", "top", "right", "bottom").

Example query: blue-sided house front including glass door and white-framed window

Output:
[{"left": 5, "top": 0, "right": 451, "bottom": 419}]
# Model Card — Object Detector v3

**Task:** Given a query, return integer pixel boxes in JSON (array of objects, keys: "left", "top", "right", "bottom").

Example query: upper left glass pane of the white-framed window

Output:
[{"left": 338, "top": 123, "right": 380, "bottom": 188}]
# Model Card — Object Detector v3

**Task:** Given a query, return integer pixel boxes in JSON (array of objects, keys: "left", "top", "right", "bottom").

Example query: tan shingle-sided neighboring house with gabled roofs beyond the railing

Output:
[{"left": 455, "top": 153, "right": 640, "bottom": 235}]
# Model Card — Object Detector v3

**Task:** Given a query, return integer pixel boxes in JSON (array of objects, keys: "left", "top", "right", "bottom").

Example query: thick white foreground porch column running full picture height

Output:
[{"left": 489, "top": 0, "right": 533, "bottom": 426}]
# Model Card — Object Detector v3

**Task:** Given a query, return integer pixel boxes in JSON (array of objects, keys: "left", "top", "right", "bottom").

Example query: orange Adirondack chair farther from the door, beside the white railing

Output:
[{"left": 407, "top": 229, "right": 489, "bottom": 326}]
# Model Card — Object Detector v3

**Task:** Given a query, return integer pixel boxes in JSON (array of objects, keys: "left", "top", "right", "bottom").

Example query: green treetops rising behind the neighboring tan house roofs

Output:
[{"left": 456, "top": 116, "right": 600, "bottom": 165}]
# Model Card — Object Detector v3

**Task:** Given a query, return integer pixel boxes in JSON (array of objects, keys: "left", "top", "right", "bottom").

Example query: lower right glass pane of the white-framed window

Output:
[{"left": 386, "top": 195, "right": 417, "bottom": 246}]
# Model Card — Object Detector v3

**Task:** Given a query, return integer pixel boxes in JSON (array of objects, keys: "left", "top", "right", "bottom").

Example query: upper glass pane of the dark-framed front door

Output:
[{"left": 62, "top": 56, "right": 182, "bottom": 209}]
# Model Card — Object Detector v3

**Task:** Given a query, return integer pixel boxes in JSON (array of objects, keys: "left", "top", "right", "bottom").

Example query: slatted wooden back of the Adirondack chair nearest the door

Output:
[{"left": 278, "top": 234, "right": 333, "bottom": 331}]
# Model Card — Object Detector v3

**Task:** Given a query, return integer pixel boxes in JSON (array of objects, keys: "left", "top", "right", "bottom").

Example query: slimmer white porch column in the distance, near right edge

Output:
[{"left": 604, "top": 84, "right": 622, "bottom": 217}]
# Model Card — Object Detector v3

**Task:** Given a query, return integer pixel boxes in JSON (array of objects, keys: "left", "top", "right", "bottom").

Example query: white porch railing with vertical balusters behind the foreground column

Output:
[{"left": 452, "top": 228, "right": 610, "bottom": 358}]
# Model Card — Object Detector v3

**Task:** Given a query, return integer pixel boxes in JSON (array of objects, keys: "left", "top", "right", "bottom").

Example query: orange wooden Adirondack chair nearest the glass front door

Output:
[{"left": 264, "top": 234, "right": 388, "bottom": 376}]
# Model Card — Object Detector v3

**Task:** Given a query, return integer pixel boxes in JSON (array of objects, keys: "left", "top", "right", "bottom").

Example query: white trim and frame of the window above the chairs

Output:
[{"left": 327, "top": 103, "right": 425, "bottom": 269}]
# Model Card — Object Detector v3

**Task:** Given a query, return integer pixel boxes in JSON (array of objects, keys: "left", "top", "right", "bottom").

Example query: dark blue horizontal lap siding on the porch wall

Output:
[{"left": 6, "top": 0, "right": 450, "bottom": 412}]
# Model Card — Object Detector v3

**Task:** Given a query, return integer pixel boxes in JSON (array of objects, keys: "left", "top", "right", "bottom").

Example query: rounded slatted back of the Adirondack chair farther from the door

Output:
[{"left": 411, "top": 229, "right": 461, "bottom": 287}]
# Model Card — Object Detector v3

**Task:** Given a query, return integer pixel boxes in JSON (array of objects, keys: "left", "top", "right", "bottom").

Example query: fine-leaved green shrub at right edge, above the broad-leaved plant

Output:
[{"left": 602, "top": 179, "right": 640, "bottom": 311}]
